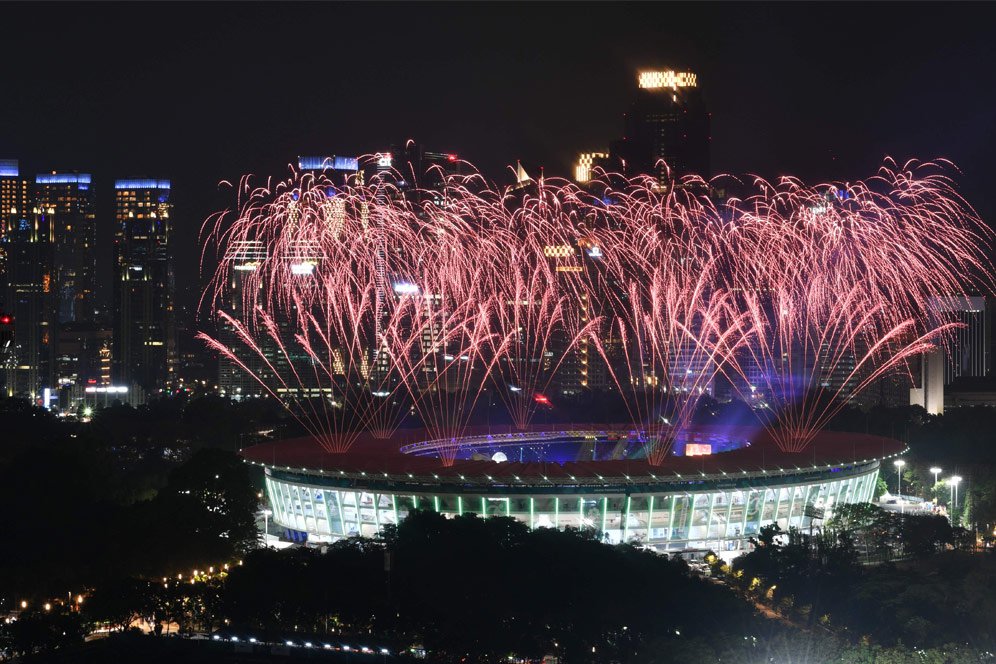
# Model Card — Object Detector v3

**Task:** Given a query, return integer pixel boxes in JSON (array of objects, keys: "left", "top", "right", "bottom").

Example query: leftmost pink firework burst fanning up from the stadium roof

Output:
[{"left": 201, "top": 169, "right": 406, "bottom": 452}]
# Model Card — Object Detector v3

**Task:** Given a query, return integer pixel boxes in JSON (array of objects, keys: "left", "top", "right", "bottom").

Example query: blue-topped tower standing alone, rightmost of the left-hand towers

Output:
[{"left": 111, "top": 179, "right": 176, "bottom": 396}]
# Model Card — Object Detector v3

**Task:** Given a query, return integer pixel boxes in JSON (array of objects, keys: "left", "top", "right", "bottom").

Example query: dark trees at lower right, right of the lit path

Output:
[{"left": 709, "top": 505, "right": 996, "bottom": 648}]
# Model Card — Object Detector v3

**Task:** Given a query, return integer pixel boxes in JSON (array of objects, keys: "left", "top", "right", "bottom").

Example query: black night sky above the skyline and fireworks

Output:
[{"left": 0, "top": 2, "right": 996, "bottom": 312}]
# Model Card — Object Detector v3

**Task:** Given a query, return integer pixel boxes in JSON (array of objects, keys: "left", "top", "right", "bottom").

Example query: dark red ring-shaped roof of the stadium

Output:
[{"left": 242, "top": 424, "right": 906, "bottom": 482}]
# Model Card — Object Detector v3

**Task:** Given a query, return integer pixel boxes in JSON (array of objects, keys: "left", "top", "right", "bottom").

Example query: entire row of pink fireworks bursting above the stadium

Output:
[{"left": 201, "top": 162, "right": 992, "bottom": 465}]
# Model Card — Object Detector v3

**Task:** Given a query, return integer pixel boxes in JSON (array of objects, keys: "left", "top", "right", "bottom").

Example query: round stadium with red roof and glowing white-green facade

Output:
[{"left": 242, "top": 425, "right": 905, "bottom": 552}]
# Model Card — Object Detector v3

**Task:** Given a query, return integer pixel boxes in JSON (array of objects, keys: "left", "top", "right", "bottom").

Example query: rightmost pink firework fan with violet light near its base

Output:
[{"left": 716, "top": 162, "right": 992, "bottom": 452}]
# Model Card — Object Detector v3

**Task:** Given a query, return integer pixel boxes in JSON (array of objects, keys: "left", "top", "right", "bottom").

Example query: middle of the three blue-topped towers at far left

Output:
[{"left": 34, "top": 171, "right": 97, "bottom": 323}]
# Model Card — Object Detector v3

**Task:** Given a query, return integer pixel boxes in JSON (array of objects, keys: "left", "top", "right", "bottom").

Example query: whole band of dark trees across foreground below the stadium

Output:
[{"left": 13, "top": 512, "right": 996, "bottom": 664}]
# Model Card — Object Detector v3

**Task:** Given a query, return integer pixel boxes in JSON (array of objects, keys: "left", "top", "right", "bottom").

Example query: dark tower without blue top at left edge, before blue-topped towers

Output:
[{"left": 2, "top": 208, "right": 56, "bottom": 396}]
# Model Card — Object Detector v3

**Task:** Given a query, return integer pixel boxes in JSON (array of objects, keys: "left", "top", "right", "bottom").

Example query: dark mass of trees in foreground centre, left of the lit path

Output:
[{"left": 76, "top": 512, "right": 754, "bottom": 661}]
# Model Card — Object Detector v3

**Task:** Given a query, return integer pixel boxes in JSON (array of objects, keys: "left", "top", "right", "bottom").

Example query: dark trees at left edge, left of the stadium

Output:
[{"left": 0, "top": 442, "right": 258, "bottom": 600}]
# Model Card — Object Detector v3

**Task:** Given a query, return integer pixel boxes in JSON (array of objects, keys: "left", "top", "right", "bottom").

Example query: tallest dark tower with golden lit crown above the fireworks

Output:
[{"left": 610, "top": 69, "right": 711, "bottom": 186}]
